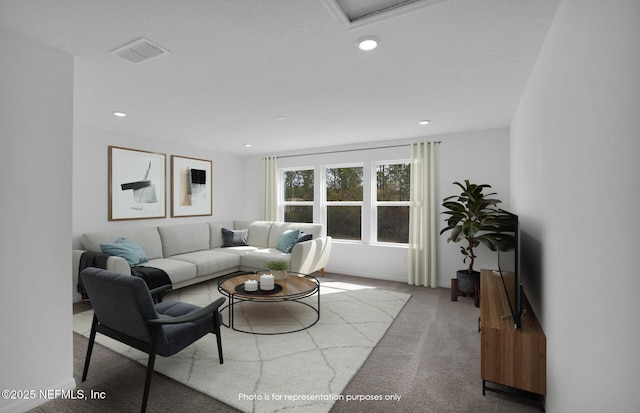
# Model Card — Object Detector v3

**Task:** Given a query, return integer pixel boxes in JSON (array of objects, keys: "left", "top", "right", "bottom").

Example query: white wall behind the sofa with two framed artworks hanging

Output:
[{"left": 73, "top": 124, "right": 248, "bottom": 301}]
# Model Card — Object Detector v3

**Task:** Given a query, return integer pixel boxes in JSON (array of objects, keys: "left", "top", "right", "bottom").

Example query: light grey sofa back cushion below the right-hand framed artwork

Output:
[{"left": 158, "top": 222, "right": 209, "bottom": 258}]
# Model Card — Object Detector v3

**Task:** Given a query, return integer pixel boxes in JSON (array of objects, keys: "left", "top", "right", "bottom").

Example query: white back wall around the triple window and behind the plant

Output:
[{"left": 244, "top": 128, "right": 509, "bottom": 287}]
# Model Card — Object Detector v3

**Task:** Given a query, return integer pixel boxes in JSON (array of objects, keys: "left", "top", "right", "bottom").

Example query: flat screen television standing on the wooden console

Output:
[{"left": 495, "top": 209, "right": 523, "bottom": 329}]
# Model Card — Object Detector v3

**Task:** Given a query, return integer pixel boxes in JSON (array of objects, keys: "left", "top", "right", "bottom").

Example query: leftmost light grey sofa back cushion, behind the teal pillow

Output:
[{"left": 80, "top": 227, "right": 162, "bottom": 260}]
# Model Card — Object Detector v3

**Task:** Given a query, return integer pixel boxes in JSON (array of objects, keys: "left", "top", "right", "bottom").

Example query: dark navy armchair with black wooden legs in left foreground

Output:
[{"left": 80, "top": 267, "right": 225, "bottom": 413}]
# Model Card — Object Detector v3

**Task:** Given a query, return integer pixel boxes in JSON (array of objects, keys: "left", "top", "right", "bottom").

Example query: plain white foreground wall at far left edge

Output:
[{"left": 0, "top": 31, "right": 76, "bottom": 412}]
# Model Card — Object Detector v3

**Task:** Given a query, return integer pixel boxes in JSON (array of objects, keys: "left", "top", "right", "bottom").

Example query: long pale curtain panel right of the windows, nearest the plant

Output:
[{"left": 409, "top": 142, "right": 438, "bottom": 287}]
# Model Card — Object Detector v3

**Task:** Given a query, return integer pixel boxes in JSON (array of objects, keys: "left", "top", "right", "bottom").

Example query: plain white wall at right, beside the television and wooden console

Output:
[{"left": 511, "top": 0, "right": 640, "bottom": 413}]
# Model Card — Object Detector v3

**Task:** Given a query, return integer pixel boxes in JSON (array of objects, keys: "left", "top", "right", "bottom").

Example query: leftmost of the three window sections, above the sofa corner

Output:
[{"left": 282, "top": 169, "right": 313, "bottom": 222}]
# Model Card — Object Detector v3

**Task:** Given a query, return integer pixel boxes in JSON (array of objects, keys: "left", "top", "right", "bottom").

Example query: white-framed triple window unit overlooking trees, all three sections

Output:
[{"left": 279, "top": 146, "right": 411, "bottom": 247}]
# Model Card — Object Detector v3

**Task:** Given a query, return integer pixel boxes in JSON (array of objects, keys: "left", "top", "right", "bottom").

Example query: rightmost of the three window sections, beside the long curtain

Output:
[{"left": 373, "top": 163, "right": 411, "bottom": 243}]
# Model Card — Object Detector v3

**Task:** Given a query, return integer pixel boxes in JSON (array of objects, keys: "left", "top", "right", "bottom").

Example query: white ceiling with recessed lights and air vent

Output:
[{"left": 0, "top": 0, "right": 559, "bottom": 155}]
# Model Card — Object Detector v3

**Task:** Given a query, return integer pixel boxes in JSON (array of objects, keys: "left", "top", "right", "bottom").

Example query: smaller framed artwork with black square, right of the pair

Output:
[{"left": 171, "top": 155, "right": 213, "bottom": 217}]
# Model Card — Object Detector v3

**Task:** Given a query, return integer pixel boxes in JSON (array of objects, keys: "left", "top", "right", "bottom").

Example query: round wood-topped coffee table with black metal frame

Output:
[{"left": 218, "top": 272, "right": 320, "bottom": 335}]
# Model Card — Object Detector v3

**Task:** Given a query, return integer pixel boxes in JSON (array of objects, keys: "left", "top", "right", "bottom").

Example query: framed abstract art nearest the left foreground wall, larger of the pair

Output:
[{"left": 109, "top": 146, "right": 167, "bottom": 221}]
